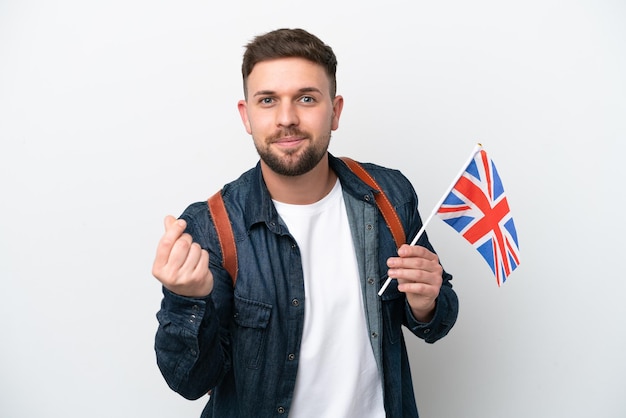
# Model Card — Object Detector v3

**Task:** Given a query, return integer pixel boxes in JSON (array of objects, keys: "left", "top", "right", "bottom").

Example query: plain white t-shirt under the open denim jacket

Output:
[{"left": 274, "top": 181, "right": 385, "bottom": 418}]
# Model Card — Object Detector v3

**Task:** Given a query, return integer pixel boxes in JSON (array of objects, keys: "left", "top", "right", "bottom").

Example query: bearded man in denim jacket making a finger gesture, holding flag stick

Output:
[{"left": 152, "top": 29, "right": 458, "bottom": 418}]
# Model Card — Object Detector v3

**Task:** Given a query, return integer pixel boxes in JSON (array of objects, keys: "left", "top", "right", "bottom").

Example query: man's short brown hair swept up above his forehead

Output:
[{"left": 241, "top": 29, "right": 337, "bottom": 99}]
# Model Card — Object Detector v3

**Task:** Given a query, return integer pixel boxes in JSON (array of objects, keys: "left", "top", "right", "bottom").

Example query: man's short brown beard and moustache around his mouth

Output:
[{"left": 254, "top": 130, "right": 331, "bottom": 177}]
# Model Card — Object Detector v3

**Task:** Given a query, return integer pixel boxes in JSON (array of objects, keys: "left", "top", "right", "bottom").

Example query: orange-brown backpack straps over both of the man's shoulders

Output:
[{"left": 207, "top": 157, "right": 406, "bottom": 286}]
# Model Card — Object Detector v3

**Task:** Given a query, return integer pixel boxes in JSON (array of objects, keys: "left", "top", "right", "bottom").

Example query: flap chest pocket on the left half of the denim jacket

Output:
[{"left": 233, "top": 295, "right": 272, "bottom": 369}]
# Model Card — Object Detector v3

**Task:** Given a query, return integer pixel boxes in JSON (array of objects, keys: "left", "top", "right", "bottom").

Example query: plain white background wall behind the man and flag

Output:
[{"left": 0, "top": 0, "right": 626, "bottom": 418}]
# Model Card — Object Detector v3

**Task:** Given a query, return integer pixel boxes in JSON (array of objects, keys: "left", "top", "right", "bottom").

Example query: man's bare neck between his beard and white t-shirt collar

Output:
[{"left": 261, "top": 154, "right": 337, "bottom": 205}]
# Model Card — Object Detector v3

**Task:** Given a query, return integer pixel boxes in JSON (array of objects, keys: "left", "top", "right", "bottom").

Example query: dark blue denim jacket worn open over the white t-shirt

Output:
[{"left": 155, "top": 155, "right": 458, "bottom": 418}]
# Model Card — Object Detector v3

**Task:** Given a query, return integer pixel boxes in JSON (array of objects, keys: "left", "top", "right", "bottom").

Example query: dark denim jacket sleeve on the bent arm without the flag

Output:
[{"left": 155, "top": 204, "right": 232, "bottom": 399}]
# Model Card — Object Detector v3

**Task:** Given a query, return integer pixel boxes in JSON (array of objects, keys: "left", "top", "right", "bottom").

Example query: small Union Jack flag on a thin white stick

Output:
[{"left": 437, "top": 145, "right": 520, "bottom": 286}]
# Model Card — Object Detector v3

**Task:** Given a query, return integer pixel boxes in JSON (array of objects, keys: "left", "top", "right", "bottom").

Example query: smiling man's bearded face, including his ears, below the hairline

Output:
[{"left": 238, "top": 58, "right": 343, "bottom": 176}]
